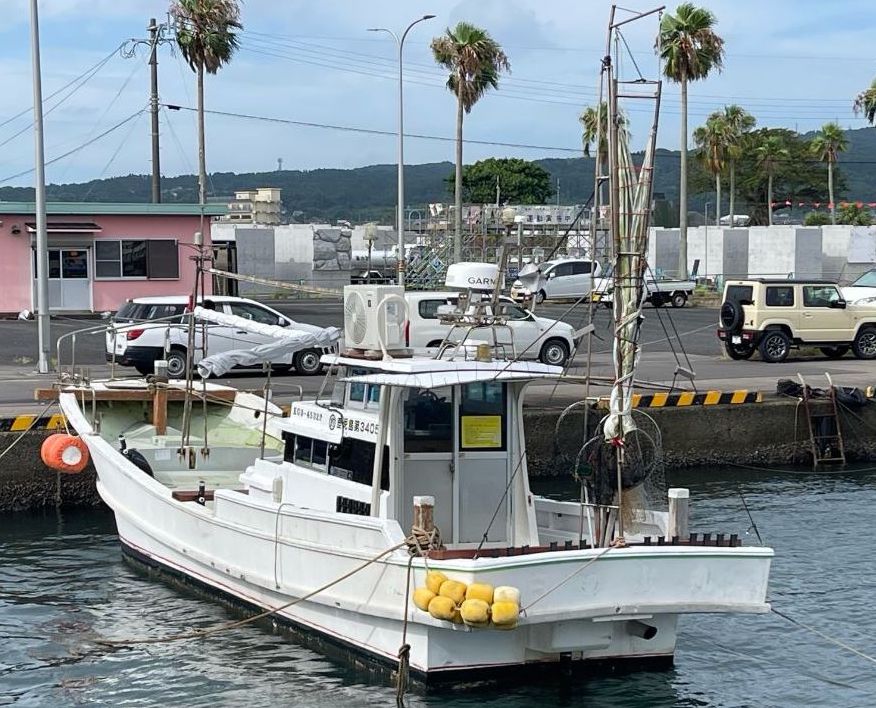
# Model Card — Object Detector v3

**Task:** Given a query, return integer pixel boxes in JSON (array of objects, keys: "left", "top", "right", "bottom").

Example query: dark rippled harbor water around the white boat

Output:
[{"left": 0, "top": 468, "right": 876, "bottom": 708}]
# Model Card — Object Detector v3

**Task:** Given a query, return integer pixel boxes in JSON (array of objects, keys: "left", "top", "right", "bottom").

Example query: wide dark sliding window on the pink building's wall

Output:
[{"left": 94, "top": 239, "right": 179, "bottom": 280}]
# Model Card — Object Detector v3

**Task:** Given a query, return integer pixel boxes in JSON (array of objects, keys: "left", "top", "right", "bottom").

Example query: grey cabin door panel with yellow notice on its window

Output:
[{"left": 454, "top": 381, "right": 512, "bottom": 545}]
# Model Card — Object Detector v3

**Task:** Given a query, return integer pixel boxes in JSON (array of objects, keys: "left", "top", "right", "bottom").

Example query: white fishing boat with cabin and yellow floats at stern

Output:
[{"left": 46, "top": 266, "right": 773, "bottom": 682}]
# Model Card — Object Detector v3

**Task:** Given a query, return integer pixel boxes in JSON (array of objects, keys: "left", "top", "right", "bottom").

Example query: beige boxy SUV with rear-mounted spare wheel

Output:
[{"left": 718, "top": 279, "right": 876, "bottom": 362}]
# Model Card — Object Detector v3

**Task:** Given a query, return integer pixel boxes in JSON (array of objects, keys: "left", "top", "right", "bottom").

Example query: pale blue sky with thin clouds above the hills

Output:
[{"left": 0, "top": 0, "right": 876, "bottom": 191}]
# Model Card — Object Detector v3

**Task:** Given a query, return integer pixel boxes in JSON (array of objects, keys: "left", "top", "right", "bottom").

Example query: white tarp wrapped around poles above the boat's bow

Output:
[{"left": 194, "top": 307, "right": 341, "bottom": 378}]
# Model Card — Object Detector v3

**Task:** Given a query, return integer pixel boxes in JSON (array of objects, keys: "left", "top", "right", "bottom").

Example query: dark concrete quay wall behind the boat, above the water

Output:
[{"left": 6, "top": 399, "right": 876, "bottom": 511}]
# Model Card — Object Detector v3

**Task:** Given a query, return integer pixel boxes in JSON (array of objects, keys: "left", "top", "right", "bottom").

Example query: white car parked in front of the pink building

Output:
[{"left": 106, "top": 295, "right": 328, "bottom": 378}]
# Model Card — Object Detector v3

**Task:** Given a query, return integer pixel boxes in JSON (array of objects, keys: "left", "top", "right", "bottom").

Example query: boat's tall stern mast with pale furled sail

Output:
[{"left": 597, "top": 5, "right": 663, "bottom": 544}]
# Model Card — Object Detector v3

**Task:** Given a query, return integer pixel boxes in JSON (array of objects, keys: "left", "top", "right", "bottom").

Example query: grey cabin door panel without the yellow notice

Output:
[{"left": 396, "top": 386, "right": 453, "bottom": 542}]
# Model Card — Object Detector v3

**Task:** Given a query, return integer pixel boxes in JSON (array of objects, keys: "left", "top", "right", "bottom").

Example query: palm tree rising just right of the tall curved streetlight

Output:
[{"left": 431, "top": 22, "right": 511, "bottom": 263}]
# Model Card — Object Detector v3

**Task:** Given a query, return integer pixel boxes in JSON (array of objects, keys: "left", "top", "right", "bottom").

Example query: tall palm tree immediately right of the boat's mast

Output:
[{"left": 657, "top": 3, "right": 724, "bottom": 278}]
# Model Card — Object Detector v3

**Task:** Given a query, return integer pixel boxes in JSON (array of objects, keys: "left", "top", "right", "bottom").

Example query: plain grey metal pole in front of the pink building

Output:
[{"left": 30, "top": 0, "right": 51, "bottom": 374}]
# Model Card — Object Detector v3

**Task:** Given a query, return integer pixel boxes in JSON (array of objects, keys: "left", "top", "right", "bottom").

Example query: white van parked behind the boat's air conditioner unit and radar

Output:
[{"left": 405, "top": 291, "right": 575, "bottom": 366}]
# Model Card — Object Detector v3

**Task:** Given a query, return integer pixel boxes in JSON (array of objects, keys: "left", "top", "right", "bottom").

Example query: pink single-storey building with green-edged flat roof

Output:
[{"left": 0, "top": 202, "right": 226, "bottom": 313}]
